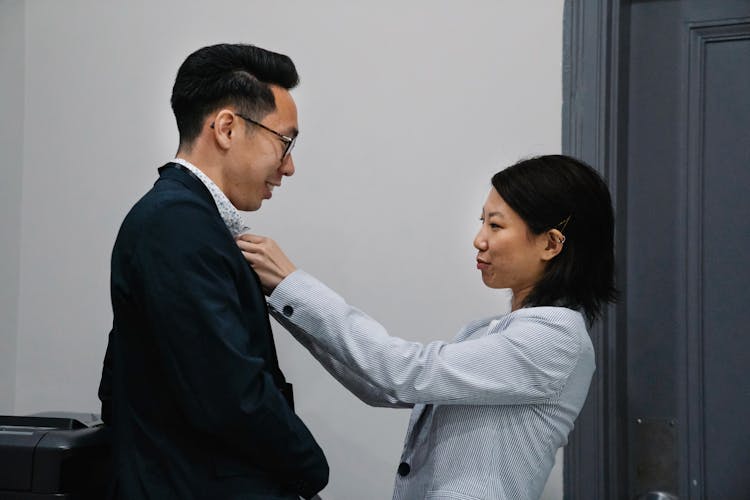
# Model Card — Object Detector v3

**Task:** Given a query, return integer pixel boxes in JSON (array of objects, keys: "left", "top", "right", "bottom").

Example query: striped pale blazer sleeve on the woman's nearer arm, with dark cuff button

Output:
[{"left": 269, "top": 270, "right": 585, "bottom": 405}]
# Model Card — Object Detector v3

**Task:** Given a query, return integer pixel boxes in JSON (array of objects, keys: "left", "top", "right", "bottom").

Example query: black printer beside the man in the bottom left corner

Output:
[{"left": 0, "top": 412, "right": 110, "bottom": 500}]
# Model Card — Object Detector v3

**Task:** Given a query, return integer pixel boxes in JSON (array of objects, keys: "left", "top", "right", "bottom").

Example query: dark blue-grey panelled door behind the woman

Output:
[{"left": 566, "top": 0, "right": 750, "bottom": 500}]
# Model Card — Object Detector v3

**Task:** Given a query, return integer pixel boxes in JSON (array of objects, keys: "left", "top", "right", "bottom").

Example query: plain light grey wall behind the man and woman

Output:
[{"left": 0, "top": 0, "right": 563, "bottom": 500}]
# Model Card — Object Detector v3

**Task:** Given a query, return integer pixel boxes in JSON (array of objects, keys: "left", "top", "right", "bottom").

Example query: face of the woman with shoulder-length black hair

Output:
[{"left": 474, "top": 188, "right": 550, "bottom": 302}]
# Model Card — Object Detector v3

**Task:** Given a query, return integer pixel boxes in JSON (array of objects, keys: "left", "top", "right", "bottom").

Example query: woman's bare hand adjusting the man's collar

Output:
[{"left": 237, "top": 234, "right": 297, "bottom": 295}]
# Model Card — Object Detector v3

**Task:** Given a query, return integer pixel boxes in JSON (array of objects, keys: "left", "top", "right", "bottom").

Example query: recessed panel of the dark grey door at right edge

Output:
[{"left": 690, "top": 31, "right": 750, "bottom": 499}]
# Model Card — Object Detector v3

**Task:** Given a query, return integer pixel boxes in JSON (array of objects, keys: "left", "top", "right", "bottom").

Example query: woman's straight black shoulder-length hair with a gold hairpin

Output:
[{"left": 492, "top": 155, "right": 617, "bottom": 323}]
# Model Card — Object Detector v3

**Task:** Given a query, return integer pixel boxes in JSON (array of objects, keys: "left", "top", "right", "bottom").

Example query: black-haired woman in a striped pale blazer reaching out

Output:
[{"left": 238, "top": 156, "right": 615, "bottom": 500}]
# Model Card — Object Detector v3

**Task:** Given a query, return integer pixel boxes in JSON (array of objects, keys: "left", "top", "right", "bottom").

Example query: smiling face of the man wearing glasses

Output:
[{"left": 224, "top": 85, "right": 298, "bottom": 211}]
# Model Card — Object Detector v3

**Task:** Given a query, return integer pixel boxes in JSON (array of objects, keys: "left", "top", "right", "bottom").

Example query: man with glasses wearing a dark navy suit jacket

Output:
[{"left": 99, "top": 44, "right": 328, "bottom": 500}]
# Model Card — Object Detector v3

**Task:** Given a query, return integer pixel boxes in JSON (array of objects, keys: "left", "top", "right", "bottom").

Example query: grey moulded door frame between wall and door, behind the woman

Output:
[{"left": 562, "top": 0, "right": 628, "bottom": 500}]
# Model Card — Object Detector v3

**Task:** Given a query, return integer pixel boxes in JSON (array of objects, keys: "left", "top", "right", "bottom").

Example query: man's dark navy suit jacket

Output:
[{"left": 99, "top": 164, "right": 328, "bottom": 500}]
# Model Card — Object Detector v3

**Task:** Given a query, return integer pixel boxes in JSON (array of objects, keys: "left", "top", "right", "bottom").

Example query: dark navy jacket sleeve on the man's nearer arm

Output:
[{"left": 132, "top": 202, "right": 328, "bottom": 497}]
